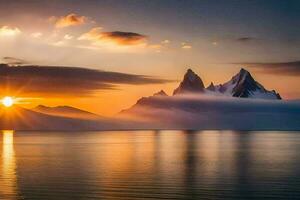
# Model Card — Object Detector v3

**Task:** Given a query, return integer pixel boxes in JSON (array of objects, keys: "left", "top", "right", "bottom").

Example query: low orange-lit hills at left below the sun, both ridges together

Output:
[{"left": 0, "top": 105, "right": 131, "bottom": 131}]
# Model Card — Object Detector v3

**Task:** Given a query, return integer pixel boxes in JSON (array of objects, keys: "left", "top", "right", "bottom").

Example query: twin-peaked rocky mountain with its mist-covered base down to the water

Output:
[{"left": 120, "top": 69, "right": 300, "bottom": 130}]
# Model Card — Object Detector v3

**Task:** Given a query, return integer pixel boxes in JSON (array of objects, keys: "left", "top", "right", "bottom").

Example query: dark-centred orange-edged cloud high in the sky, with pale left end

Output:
[{"left": 78, "top": 27, "right": 147, "bottom": 46}]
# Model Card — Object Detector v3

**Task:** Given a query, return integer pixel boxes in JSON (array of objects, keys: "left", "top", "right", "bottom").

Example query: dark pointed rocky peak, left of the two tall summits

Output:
[{"left": 173, "top": 69, "right": 204, "bottom": 95}]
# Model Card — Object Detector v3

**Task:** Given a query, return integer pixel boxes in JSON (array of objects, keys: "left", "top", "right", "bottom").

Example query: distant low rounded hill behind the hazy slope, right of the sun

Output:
[{"left": 33, "top": 105, "right": 101, "bottom": 119}]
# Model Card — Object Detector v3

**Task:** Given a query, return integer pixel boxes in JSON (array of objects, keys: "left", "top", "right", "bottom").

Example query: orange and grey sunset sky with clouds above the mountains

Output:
[{"left": 0, "top": 0, "right": 300, "bottom": 116}]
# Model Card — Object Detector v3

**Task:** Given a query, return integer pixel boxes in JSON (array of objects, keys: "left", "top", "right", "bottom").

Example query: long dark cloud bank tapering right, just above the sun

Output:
[{"left": 0, "top": 64, "right": 170, "bottom": 97}]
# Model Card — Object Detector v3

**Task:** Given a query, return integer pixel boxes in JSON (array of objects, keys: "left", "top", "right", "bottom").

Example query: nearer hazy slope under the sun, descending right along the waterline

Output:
[{"left": 0, "top": 106, "right": 131, "bottom": 131}]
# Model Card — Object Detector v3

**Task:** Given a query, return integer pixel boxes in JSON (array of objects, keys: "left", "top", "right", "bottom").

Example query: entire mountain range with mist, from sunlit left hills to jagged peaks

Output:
[{"left": 0, "top": 69, "right": 300, "bottom": 131}]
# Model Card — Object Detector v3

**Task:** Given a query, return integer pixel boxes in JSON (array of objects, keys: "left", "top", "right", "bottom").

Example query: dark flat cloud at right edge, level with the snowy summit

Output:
[{"left": 233, "top": 61, "right": 300, "bottom": 76}]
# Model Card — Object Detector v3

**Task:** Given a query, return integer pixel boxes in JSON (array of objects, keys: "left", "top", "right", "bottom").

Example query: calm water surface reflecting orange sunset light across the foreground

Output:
[{"left": 0, "top": 131, "right": 300, "bottom": 200}]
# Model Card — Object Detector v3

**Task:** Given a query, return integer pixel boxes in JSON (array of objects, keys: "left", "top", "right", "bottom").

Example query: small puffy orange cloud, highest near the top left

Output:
[{"left": 49, "top": 13, "right": 88, "bottom": 28}]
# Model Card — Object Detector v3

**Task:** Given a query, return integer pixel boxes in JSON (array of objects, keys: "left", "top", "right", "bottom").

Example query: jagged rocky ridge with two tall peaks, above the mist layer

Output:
[{"left": 121, "top": 68, "right": 281, "bottom": 116}]
